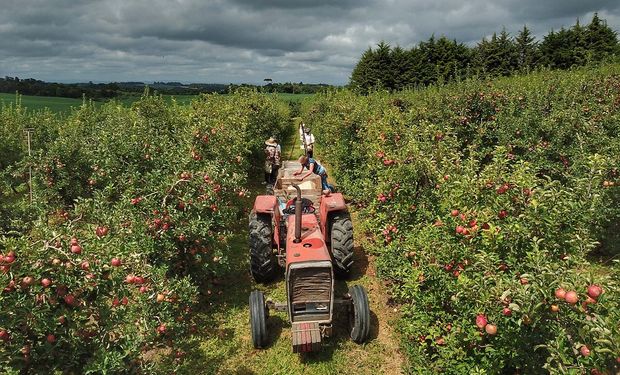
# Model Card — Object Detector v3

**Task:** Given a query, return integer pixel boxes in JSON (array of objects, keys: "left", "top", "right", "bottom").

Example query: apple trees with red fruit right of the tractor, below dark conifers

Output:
[{"left": 304, "top": 65, "right": 620, "bottom": 374}]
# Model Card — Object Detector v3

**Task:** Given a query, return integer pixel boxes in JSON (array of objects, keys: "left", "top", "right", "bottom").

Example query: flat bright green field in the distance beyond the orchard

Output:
[{"left": 0, "top": 93, "right": 313, "bottom": 113}]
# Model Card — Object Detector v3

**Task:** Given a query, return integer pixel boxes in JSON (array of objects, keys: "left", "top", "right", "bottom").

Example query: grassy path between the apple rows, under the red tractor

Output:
[{"left": 183, "top": 117, "right": 404, "bottom": 375}]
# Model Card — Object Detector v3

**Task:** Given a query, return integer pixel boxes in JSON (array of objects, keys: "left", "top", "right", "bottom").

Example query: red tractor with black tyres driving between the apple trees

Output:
[{"left": 249, "top": 162, "right": 370, "bottom": 353}]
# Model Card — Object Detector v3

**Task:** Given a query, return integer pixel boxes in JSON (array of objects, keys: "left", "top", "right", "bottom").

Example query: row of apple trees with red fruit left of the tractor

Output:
[{"left": 0, "top": 92, "right": 288, "bottom": 373}]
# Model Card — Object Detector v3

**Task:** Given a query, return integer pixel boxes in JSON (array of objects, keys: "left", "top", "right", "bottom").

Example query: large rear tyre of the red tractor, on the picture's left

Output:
[{"left": 249, "top": 213, "right": 278, "bottom": 283}]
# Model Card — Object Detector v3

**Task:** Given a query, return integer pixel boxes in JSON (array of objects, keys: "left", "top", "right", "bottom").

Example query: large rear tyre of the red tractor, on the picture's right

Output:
[{"left": 329, "top": 212, "right": 353, "bottom": 277}]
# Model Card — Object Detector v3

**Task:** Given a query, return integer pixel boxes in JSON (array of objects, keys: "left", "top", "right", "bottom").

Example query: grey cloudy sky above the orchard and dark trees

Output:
[{"left": 0, "top": 0, "right": 620, "bottom": 84}]
